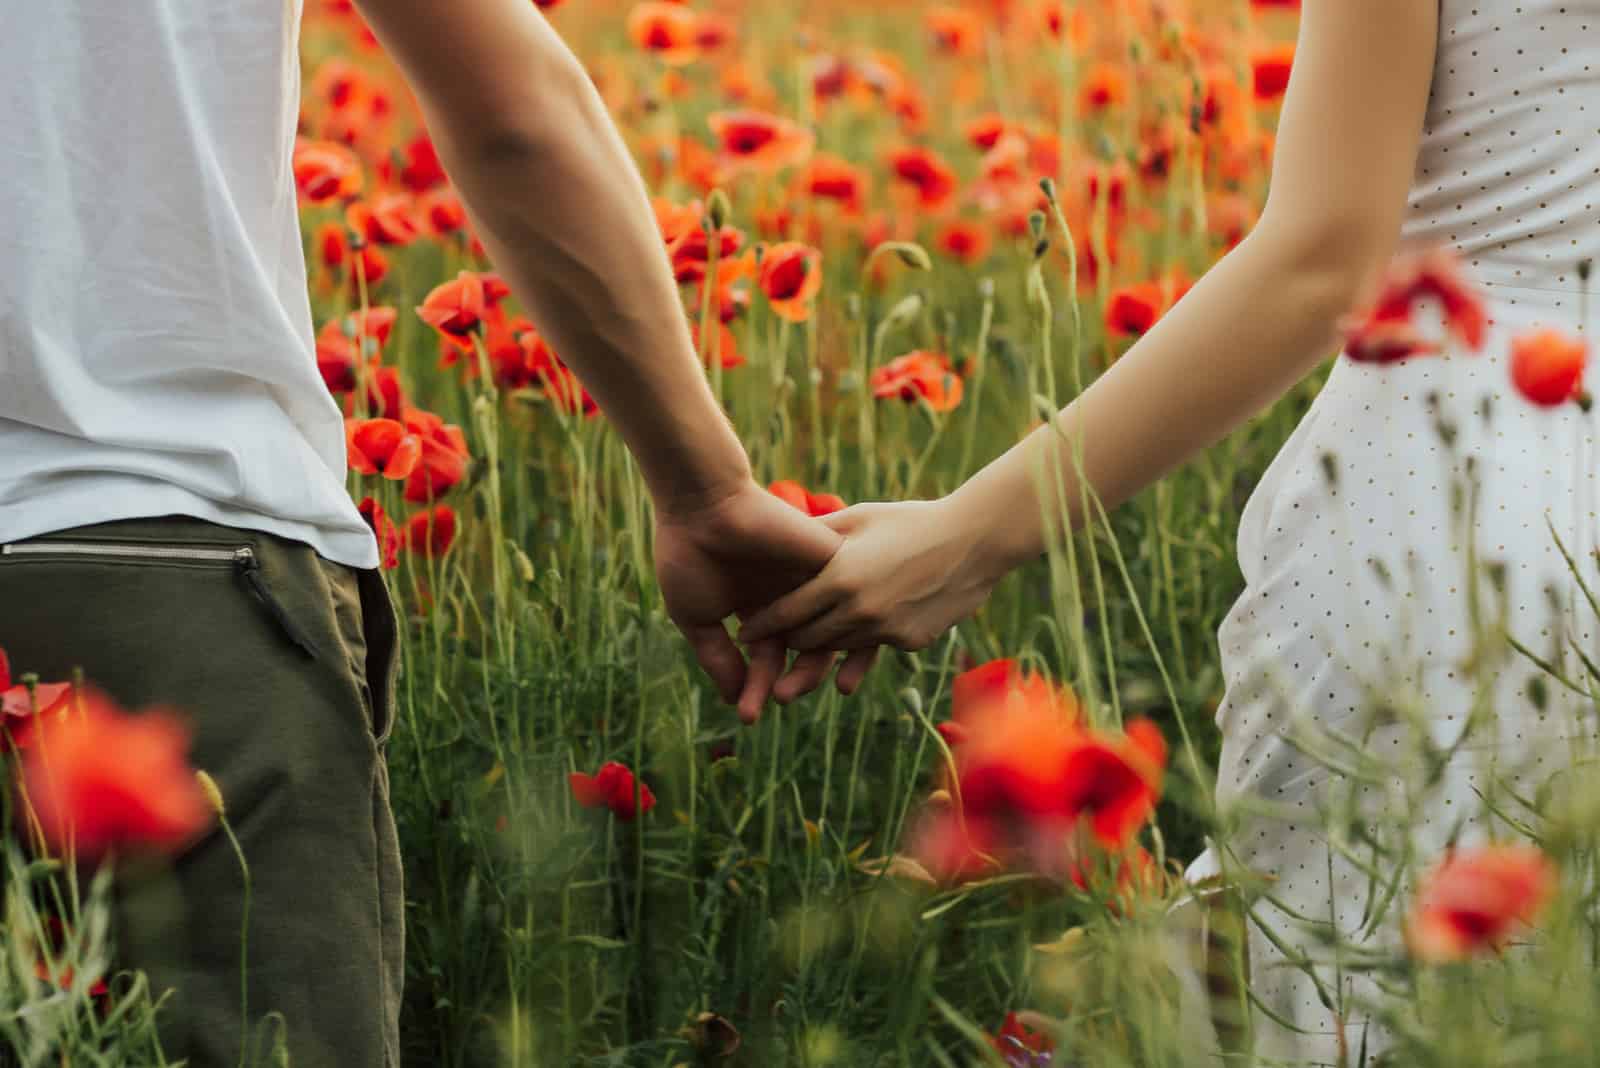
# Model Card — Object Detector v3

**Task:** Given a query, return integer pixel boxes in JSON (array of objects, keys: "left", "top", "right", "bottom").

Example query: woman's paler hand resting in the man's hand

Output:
[{"left": 739, "top": 497, "right": 1010, "bottom": 661}]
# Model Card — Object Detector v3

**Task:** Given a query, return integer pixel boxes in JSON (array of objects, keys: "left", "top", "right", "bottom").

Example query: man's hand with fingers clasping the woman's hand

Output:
[{"left": 656, "top": 481, "right": 874, "bottom": 723}]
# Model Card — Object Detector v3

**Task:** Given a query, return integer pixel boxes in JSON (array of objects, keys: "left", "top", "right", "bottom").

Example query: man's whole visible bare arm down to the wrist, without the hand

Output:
[{"left": 363, "top": 0, "right": 749, "bottom": 510}]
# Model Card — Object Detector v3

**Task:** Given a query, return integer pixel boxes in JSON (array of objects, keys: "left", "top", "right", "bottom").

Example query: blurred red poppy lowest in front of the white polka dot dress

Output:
[{"left": 1405, "top": 844, "right": 1557, "bottom": 962}]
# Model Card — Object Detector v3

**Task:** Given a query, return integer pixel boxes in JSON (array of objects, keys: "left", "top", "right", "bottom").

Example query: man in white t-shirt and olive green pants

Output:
[{"left": 0, "top": 0, "right": 867, "bottom": 1068}]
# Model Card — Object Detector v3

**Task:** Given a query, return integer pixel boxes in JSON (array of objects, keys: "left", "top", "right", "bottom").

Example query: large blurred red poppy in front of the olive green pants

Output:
[{"left": 22, "top": 691, "right": 214, "bottom": 860}]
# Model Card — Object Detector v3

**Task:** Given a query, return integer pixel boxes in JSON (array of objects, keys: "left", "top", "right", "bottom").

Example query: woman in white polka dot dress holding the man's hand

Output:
[{"left": 742, "top": 0, "right": 1600, "bottom": 1063}]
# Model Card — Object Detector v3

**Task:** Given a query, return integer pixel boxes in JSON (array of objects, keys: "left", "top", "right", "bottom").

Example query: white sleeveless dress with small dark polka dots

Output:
[{"left": 1189, "top": 0, "right": 1600, "bottom": 1065}]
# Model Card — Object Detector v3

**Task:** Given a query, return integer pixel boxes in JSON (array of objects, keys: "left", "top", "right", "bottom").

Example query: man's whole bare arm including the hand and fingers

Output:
[{"left": 358, "top": 0, "right": 867, "bottom": 719}]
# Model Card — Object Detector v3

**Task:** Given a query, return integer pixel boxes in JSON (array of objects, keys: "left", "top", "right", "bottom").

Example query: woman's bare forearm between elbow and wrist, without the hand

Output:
[{"left": 950, "top": 233, "right": 1378, "bottom": 569}]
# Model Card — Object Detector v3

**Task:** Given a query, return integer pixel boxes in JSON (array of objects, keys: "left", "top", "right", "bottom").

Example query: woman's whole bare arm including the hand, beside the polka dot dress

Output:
[{"left": 741, "top": 0, "right": 1438, "bottom": 658}]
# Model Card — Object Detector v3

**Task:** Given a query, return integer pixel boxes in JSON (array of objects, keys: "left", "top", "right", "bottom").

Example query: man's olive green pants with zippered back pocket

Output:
[{"left": 0, "top": 516, "right": 405, "bottom": 1068}]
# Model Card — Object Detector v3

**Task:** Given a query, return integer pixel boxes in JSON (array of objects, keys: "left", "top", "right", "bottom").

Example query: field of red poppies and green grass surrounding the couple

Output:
[{"left": 15, "top": 0, "right": 1600, "bottom": 1068}]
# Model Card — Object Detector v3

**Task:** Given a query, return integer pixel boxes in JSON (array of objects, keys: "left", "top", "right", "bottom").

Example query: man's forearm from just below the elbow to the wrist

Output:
[{"left": 451, "top": 85, "right": 749, "bottom": 504}]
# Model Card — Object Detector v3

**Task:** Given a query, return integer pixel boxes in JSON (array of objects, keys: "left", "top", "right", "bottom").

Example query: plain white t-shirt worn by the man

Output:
[{"left": 0, "top": 0, "right": 378, "bottom": 568}]
